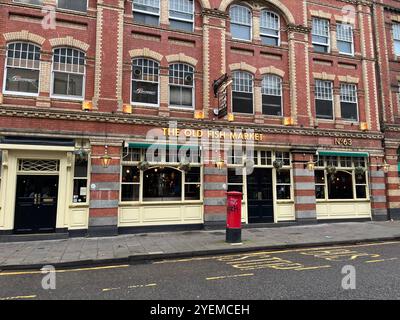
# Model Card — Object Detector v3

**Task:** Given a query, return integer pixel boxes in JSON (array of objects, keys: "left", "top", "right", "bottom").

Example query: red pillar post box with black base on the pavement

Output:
[{"left": 226, "top": 191, "right": 242, "bottom": 243}]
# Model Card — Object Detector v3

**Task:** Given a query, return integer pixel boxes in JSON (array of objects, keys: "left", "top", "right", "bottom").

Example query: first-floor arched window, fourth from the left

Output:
[{"left": 169, "top": 63, "right": 194, "bottom": 109}]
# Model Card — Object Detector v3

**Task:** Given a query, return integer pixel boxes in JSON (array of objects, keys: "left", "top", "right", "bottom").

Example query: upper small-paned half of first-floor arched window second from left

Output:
[{"left": 53, "top": 48, "right": 85, "bottom": 74}]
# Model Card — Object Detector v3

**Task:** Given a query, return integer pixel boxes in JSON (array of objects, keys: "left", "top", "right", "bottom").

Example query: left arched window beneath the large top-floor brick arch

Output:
[{"left": 229, "top": 5, "right": 252, "bottom": 41}]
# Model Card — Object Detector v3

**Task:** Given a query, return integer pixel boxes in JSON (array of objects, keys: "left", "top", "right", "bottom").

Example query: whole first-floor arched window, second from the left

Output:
[{"left": 52, "top": 48, "right": 85, "bottom": 99}]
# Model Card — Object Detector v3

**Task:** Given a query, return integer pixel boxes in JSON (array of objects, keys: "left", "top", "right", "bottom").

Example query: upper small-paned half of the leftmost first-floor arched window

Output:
[{"left": 7, "top": 42, "right": 40, "bottom": 70}]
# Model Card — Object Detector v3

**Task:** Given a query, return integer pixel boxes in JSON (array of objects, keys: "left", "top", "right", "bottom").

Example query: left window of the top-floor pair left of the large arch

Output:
[{"left": 133, "top": 0, "right": 160, "bottom": 26}]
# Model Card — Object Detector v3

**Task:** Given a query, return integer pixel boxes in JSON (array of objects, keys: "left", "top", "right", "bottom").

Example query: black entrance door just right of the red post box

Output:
[{"left": 247, "top": 168, "right": 274, "bottom": 223}]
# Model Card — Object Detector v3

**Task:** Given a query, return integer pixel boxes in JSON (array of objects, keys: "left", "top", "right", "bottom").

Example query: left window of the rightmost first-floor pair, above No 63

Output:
[{"left": 315, "top": 80, "right": 333, "bottom": 120}]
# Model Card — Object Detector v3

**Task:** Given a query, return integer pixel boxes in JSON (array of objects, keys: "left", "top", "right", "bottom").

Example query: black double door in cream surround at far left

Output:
[{"left": 14, "top": 175, "right": 58, "bottom": 233}]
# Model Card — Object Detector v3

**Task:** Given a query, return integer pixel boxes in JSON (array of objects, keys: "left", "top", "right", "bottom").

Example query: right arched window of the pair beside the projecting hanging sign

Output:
[{"left": 261, "top": 74, "right": 282, "bottom": 116}]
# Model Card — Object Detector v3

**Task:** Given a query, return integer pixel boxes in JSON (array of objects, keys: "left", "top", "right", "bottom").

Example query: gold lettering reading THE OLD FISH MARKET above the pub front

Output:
[{"left": 163, "top": 128, "right": 263, "bottom": 141}]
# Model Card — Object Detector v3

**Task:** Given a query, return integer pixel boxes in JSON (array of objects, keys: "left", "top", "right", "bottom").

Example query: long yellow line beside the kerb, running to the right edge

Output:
[{"left": 153, "top": 241, "right": 400, "bottom": 264}]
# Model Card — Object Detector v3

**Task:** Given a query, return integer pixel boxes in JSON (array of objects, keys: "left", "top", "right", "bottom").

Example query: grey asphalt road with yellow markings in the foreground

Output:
[{"left": 0, "top": 242, "right": 400, "bottom": 300}]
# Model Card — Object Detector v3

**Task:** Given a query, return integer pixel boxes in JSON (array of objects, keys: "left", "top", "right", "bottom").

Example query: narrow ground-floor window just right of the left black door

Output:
[{"left": 72, "top": 156, "right": 89, "bottom": 203}]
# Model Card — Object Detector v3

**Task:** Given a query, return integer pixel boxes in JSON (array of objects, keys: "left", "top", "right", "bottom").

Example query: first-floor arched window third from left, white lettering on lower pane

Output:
[{"left": 132, "top": 58, "right": 159, "bottom": 105}]
